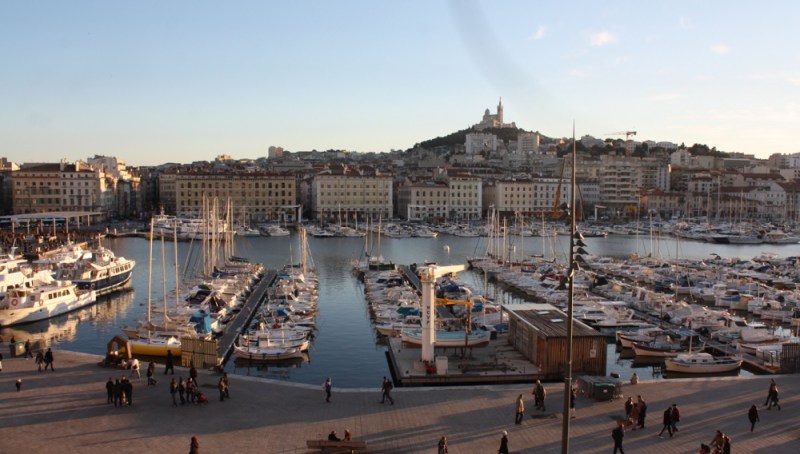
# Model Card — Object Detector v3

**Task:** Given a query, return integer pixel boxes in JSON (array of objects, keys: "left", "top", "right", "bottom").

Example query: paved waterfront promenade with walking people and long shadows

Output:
[{"left": 0, "top": 345, "right": 800, "bottom": 454}]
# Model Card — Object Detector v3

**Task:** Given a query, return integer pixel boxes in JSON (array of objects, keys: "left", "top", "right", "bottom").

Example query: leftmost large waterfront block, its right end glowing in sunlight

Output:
[{"left": 12, "top": 160, "right": 116, "bottom": 216}]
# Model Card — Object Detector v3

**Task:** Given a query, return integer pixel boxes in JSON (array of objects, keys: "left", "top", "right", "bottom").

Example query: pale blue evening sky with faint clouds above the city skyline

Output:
[{"left": 0, "top": 0, "right": 800, "bottom": 165}]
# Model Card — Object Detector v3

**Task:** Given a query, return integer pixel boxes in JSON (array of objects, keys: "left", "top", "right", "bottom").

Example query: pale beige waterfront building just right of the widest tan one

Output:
[{"left": 311, "top": 164, "right": 394, "bottom": 220}]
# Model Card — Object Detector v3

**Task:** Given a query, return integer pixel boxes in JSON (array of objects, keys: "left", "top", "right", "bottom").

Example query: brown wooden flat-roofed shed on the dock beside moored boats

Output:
[{"left": 503, "top": 303, "right": 606, "bottom": 380}]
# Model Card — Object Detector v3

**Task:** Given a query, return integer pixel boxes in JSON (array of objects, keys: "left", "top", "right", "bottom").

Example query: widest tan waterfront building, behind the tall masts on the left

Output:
[{"left": 174, "top": 172, "right": 298, "bottom": 222}]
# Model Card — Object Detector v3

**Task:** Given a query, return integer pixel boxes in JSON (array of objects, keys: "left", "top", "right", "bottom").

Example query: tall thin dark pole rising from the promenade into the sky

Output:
[{"left": 561, "top": 122, "right": 577, "bottom": 454}]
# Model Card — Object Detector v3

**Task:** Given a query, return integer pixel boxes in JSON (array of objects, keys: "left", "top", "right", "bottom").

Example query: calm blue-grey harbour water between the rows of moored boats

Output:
[{"left": 6, "top": 235, "right": 800, "bottom": 387}]
